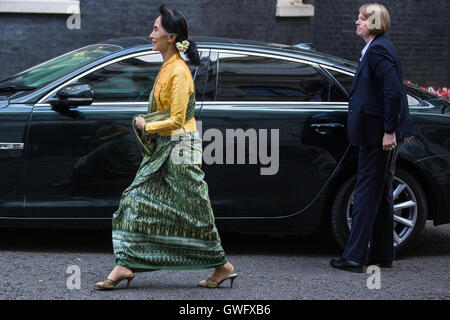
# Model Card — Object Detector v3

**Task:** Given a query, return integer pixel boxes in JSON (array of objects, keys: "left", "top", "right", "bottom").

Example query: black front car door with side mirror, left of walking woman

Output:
[{"left": 26, "top": 52, "right": 209, "bottom": 219}]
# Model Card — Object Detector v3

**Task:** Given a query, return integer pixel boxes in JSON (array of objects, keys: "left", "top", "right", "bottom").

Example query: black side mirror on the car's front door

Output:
[{"left": 49, "top": 82, "right": 94, "bottom": 108}]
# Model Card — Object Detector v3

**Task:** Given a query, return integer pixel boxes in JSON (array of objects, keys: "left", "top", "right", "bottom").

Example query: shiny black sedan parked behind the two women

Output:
[{"left": 0, "top": 37, "right": 450, "bottom": 254}]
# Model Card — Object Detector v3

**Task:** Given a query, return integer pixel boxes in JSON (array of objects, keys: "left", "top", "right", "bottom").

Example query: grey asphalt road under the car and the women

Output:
[{"left": 0, "top": 224, "right": 450, "bottom": 300}]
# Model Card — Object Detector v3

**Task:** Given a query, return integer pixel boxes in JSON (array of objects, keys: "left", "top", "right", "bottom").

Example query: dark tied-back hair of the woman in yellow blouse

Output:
[{"left": 159, "top": 5, "right": 200, "bottom": 66}]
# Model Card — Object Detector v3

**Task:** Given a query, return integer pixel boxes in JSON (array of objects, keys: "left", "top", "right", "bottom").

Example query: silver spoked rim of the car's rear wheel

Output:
[{"left": 346, "top": 177, "right": 418, "bottom": 247}]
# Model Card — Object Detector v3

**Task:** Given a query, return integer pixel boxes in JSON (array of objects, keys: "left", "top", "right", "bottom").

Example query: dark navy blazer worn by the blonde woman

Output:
[{"left": 347, "top": 34, "right": 413, "bottom": 146}]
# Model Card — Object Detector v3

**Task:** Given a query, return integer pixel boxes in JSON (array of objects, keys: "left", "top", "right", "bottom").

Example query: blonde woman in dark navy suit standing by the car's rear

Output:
[{"left": 330, "top": 3, "right": 413, "bottom": 272}]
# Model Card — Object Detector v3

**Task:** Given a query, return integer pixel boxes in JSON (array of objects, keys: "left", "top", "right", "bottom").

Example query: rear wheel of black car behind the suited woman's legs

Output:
[{"left": 331, "top": 168, "right": 427, "bottom": 255}]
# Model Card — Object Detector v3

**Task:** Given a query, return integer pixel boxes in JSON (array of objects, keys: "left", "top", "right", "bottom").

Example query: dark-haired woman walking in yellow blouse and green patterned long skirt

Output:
[{"left": 96, "top": 6, "right": 237, "bottom": 290}]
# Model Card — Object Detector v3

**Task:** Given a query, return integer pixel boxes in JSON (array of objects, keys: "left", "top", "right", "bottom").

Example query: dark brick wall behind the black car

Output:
[{"left": 0, "top": 0, "right": 450, "bottom": 87}]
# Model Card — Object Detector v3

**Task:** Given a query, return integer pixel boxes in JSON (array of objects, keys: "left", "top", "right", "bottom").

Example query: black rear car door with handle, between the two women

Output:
[{"left": 200, "top": 50, "right": 348, "bottom": 217}]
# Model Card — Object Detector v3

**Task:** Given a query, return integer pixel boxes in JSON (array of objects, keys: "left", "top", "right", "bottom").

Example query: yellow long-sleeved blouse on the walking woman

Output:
[{"left": 145, "top": 52, "right": 195, "bottom": 136}]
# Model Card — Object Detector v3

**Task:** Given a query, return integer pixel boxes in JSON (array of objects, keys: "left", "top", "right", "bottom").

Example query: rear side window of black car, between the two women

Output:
[{"left": 216, "top": 52, "right": 329, "bottom": 102}]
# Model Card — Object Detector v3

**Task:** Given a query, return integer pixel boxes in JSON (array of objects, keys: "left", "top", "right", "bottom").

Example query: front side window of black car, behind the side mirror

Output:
[{"left": 78, "top": 53, "right": 205, "bottom": 102}]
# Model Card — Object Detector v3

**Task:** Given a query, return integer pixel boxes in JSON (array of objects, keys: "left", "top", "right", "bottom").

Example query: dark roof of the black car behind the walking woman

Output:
[{"left": 101, "top": 36, "right": 358, "bottom": 72}]
